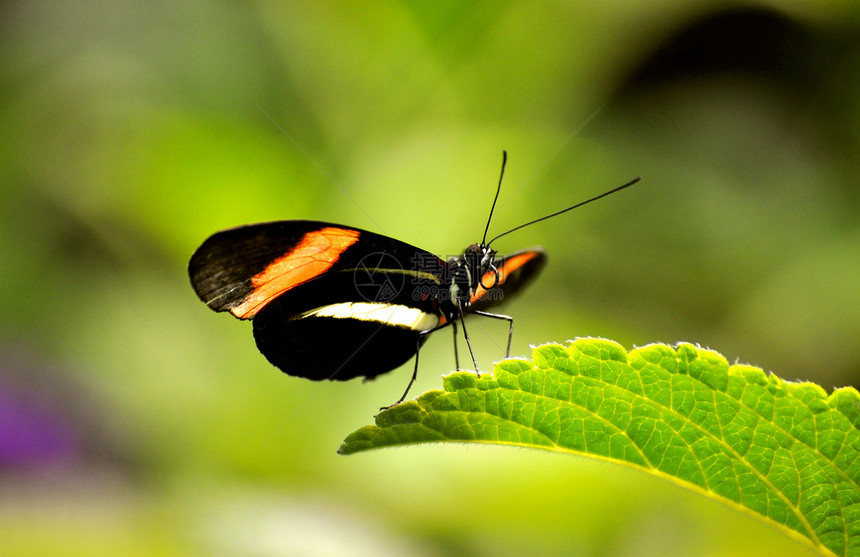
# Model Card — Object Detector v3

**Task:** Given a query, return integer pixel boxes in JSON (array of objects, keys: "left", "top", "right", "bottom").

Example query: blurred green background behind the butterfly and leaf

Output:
[{"left": 0, "top": 0, "right": 860, "bottom": 557}]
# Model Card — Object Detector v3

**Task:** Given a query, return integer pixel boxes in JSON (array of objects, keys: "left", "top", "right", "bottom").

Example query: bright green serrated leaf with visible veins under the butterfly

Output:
[{"left": 338, "top": 339, "right": 860, "bottom": 555}]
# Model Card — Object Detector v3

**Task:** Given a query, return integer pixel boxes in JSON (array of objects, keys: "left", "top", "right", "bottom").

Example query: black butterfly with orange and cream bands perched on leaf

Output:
[{"left": 188, "top": 153, "right": 639, "bottom": 408}]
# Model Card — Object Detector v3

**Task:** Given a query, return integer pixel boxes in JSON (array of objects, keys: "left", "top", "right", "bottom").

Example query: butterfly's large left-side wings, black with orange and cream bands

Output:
[{"left": 189, "top": 221, "right": 445, "bottom": 380}]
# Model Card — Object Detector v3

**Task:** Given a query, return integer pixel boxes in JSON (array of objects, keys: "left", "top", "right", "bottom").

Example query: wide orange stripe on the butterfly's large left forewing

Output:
[{"left": 230, "top": 227, "right": 359, "bottom": 319}]
